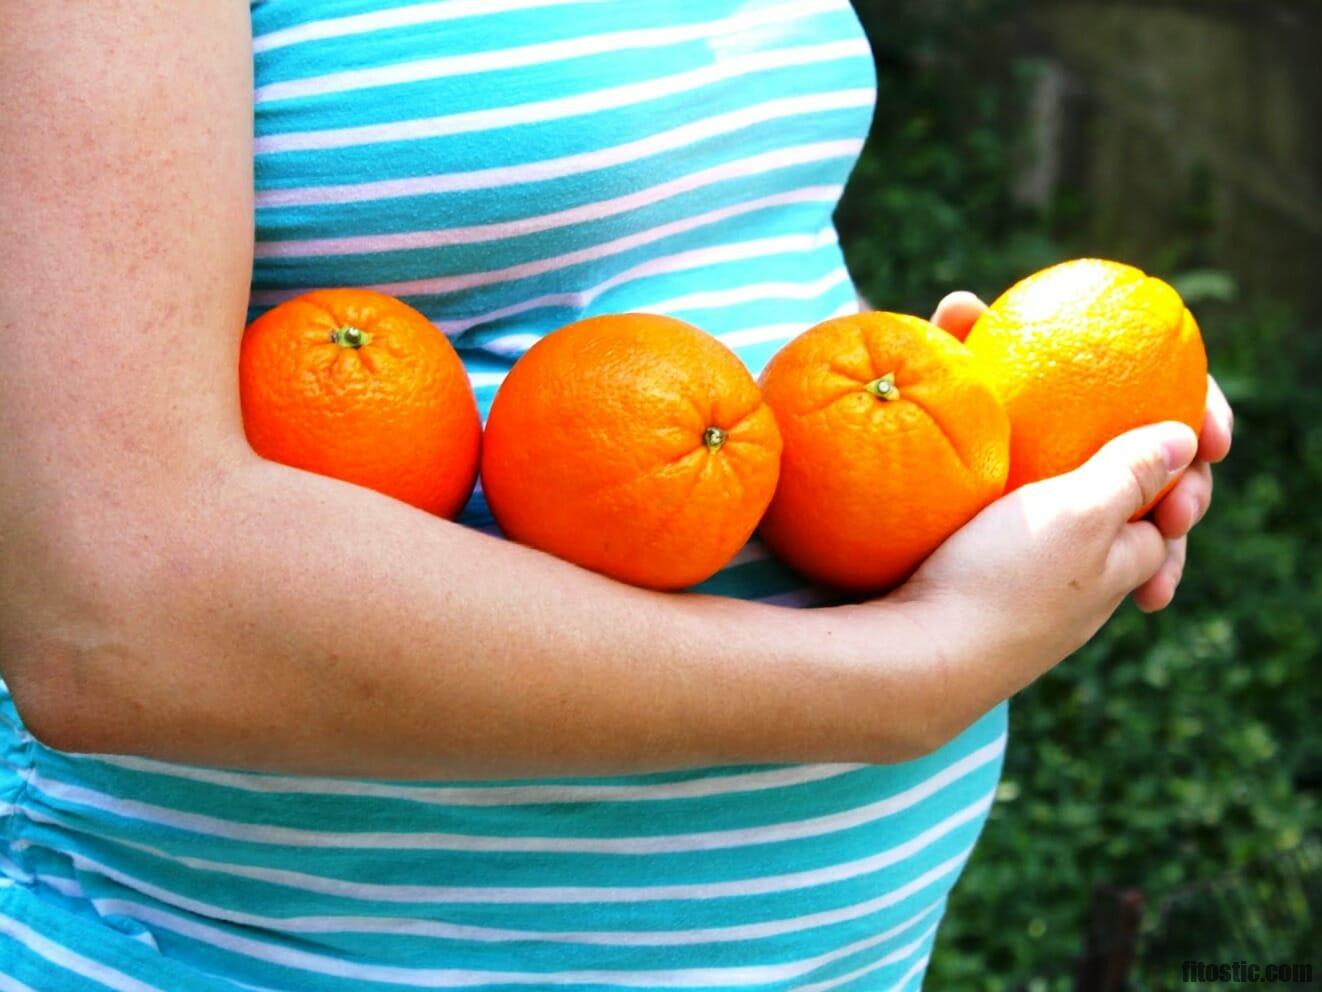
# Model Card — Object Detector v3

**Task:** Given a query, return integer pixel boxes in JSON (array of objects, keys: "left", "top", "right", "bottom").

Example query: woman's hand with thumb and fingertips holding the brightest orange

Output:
[{"left": 824, "top": 285, "right": 1229, "bottom": 743}]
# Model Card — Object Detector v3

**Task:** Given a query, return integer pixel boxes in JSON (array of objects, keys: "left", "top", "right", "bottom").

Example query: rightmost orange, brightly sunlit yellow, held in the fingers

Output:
[{"left": 965, "top": 258, "right": 1207, "bottom": 520}]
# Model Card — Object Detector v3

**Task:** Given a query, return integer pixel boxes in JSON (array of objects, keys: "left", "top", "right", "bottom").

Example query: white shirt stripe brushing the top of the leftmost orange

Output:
[{"left": 251, "top": 184, "right": 843, "bottom": 305}]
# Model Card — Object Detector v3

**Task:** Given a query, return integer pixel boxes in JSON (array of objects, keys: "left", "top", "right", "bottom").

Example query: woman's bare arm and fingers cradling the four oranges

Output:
[{"left": 0, "top": 9, "right": 1229, "bottom": 779}]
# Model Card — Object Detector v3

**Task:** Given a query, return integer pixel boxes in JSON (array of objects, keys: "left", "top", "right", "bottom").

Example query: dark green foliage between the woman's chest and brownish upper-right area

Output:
[{"left": 836, "top": 0, "right": 1059, "bottom": 315}]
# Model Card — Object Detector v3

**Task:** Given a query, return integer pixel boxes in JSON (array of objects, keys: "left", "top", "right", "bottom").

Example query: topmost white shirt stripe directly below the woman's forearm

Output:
[{"left": 79, "top": 754, "right": 867, "bottom": 806}]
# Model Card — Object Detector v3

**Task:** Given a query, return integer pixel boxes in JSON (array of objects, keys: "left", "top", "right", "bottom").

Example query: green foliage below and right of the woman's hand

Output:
[{"left": 932, "top": 311, "right": 1322, "bottom": 988}]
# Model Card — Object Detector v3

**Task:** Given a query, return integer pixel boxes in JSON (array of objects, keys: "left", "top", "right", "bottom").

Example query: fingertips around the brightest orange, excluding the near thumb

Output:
[{"left": 932, "top": 291, "right": 1235, "bottom": 612}]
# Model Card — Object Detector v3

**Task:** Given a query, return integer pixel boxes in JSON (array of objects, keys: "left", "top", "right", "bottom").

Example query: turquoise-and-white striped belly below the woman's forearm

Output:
[{"left": 0, "top": 669, "right": 1006, "bottom": 989}]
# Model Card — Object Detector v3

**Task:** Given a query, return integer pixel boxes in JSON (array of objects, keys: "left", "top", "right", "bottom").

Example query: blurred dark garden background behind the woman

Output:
[{"left": 837, "top": 0, "right": 1322, "bottom": 992}]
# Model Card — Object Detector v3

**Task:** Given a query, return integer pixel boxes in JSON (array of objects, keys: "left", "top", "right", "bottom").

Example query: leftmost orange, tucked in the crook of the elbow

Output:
[{"left": 239, "top": 290, "right": 481, "bottom": 517}]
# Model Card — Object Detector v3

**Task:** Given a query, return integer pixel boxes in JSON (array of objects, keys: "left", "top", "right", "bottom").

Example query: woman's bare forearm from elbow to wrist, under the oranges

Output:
[{"left": 16, "top": 456, "right": 927, "bottom": 778}]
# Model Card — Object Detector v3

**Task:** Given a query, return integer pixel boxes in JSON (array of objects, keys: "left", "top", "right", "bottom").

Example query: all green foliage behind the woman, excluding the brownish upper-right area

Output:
[{"left": 837, "top": 0, "right": 1322, "bottom": 992}]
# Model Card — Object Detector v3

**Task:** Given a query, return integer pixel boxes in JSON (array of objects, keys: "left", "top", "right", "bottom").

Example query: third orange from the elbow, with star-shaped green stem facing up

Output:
[{"left": 761, "top": 312, "right": 1010, "bottom": 591}]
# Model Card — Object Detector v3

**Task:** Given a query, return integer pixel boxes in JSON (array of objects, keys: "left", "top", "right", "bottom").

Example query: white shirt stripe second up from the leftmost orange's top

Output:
[{"left": 254, "top": 138, "right": 863, "bottom": 258}]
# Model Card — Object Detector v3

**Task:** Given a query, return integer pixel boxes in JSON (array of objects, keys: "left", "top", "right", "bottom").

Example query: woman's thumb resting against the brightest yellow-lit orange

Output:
[{"left": 1072, "top": 421, "right": 1198, "bottom": 530}]
